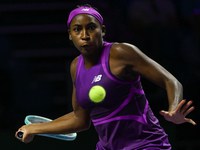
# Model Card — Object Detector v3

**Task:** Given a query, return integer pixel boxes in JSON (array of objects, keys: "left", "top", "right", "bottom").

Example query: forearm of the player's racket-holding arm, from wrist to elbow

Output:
[{"left": 28, "top": 112, "right": 88, "bottom": 135}]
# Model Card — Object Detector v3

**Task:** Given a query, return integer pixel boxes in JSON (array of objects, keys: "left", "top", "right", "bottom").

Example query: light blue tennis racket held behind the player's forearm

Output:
[{"left": 17, "top": 115, "right": 77, "bottom": 141}]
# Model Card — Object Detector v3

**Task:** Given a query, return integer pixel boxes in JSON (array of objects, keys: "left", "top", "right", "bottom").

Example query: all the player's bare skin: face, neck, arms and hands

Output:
[{"left": 15, "top": 14, "right": 196, "bottom": 143}]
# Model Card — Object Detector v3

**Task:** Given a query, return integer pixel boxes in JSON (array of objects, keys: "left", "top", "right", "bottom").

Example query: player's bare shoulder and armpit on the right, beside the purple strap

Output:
[{"left": 109, "top": 43, "right": 146, "bottom": 80}]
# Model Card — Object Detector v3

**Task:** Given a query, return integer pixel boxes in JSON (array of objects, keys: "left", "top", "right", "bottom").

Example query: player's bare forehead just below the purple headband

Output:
[{"left": 70, "top": 14, "right": 99, "bottom": 25}]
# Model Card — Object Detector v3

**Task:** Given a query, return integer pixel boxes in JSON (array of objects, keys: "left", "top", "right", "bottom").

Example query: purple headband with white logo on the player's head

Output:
[{"left": 67, "top": 6, "right": 103, "bottom": 28}]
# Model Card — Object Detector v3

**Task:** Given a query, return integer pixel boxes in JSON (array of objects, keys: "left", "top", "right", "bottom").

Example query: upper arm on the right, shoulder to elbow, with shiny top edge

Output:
[{"left": 111, "top": 43, "right": 176, "bottom": 88}]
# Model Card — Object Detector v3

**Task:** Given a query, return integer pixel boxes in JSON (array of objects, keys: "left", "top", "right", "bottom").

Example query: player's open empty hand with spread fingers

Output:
[{"left": 160, "top": 100, "right": 196, "bottom": 125}]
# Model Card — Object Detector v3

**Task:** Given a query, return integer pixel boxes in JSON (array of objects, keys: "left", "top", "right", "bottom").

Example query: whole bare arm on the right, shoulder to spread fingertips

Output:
[{"left": 110, "top": 43, "right": 195, "bottom": 125}]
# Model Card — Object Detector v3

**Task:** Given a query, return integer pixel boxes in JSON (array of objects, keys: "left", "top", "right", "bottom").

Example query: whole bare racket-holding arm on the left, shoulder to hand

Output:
[{"left": 15, "top": 56, "right": 90, "bottom": 143}]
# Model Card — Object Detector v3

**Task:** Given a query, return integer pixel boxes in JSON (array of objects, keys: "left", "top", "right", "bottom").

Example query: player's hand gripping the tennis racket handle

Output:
[{"left": 15, "top": 125, "right": 34, "bottom": 143}]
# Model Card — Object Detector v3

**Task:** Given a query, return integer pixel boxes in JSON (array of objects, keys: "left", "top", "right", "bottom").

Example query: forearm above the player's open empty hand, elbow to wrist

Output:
[{"left": 166, "top": 79, "right": 183, "bottom": 111}]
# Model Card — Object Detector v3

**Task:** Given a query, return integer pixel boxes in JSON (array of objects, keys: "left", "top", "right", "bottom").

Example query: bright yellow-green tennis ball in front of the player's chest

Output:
[{"left": 89, "top": 85, "right": 106, "bottom": 103}]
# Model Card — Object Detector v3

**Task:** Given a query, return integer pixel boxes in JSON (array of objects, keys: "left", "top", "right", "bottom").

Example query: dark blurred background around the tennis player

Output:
[{"left": 0, "top": 0, "right": 200, "bottom": 150}]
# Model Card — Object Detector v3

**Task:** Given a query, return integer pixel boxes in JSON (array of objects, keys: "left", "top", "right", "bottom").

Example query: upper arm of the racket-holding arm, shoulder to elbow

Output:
[{"left": 70, "top": 57, "right": 90, "bottom": 126}]
